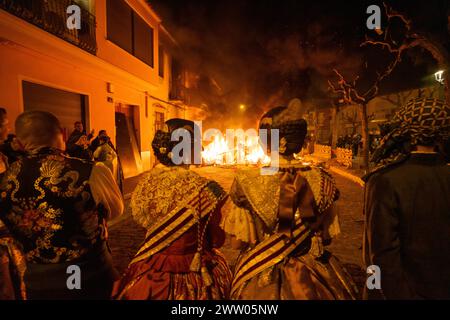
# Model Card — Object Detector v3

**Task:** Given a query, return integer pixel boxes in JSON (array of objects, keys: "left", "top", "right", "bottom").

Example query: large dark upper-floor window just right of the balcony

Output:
[{"left": 107, "top": 0, "right": 153, "bottom": 67}]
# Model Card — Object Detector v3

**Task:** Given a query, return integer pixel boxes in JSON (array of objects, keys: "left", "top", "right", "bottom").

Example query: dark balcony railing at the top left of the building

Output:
[{"left": 0, "top": 0, "right": 97, "bottom": 55}]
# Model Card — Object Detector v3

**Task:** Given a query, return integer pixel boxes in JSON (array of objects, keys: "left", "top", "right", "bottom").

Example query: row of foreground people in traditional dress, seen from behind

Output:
[{"left": 0, "top": 99, "right": 450, "bottom": 300}]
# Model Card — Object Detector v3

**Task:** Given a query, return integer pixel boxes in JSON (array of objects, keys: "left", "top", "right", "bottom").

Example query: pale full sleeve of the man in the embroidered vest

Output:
[{"left": 89, "top": 162, "right": 124, "bottom": 220}]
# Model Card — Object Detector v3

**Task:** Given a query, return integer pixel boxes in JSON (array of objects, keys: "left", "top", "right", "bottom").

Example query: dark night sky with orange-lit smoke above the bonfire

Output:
[{"left": 149, "top": 0, "right": 449, "bottom": 125}]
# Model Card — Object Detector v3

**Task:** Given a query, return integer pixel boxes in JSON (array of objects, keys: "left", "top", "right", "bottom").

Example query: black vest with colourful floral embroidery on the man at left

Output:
[{"left": 0, "top": 148, "right": 106, "bottom": 264}]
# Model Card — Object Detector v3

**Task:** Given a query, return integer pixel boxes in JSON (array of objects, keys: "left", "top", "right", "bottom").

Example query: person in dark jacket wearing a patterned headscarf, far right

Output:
[{"left": 364, "top": 99, "right": 450, "bottom": 299}]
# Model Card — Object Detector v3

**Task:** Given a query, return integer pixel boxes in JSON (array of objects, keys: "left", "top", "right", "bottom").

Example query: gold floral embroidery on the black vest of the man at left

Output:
[{"left": 2, "top": 155, "right": 101, "bottom": 263}]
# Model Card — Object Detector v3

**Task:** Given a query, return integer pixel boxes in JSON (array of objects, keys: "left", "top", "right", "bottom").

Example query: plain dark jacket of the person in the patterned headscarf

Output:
[{"left": 364, "top": 153, "right": 450, "bottom": 299}]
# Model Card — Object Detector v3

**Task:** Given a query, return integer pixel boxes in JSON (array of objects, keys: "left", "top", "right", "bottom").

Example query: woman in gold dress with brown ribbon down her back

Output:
[{"left": 223, "top": 100, "right": 357, "bottom": 300}]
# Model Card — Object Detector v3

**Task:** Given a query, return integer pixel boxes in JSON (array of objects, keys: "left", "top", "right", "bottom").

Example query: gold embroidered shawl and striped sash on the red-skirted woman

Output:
[{"left": 130, "top": 167, "right": 225, "bottom": 264}]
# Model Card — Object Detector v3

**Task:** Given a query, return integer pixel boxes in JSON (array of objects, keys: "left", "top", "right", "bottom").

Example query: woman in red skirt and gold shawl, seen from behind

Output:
[{"left": 113, "top": 119, "right": 231, "bottom": 300}]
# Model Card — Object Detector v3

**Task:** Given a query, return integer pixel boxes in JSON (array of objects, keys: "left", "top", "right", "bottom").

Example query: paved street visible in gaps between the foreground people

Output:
[{"left": 109, "top": 167, "right": 364, "bottom": 296}]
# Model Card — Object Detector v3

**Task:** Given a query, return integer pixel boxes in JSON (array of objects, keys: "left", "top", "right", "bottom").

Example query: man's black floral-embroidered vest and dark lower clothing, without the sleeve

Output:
[{"left": 0, "top": 148, "right": 119, "bottom": 299}]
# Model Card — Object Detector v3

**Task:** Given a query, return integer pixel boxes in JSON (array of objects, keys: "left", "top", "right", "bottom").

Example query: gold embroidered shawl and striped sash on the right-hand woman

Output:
[{"left": 228, "top": 164, "right": 338, "bottom": 298}]
